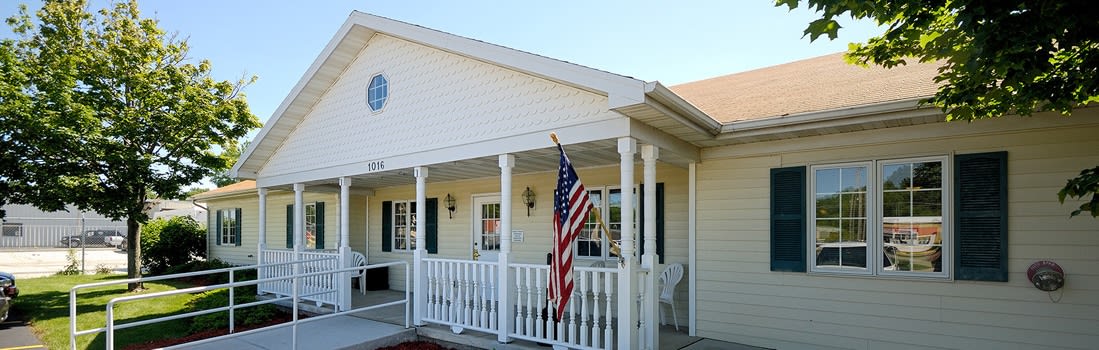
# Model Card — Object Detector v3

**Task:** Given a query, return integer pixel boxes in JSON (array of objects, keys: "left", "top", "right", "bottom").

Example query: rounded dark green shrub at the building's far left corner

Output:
[{"left": 141, "top": 217, "right": 206, "bottom": 274}]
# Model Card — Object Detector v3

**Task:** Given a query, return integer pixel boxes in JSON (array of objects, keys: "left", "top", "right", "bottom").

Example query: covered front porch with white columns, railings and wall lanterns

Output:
[{"left": 256, "top": 134, "right": 697, "bottom": 349}]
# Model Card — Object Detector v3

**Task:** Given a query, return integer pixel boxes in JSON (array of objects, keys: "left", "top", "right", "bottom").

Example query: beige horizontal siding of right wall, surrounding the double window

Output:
[{"left": 696, "top": 109, "right": 1099, "bottom": 349}]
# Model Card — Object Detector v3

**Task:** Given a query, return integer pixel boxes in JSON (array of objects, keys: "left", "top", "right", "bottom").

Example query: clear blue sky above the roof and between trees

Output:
[{"left": 0, "top": 0, "right": 881, "bottom": 129}]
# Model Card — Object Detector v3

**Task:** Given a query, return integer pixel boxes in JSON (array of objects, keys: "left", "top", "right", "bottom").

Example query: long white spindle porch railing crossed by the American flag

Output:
[{"left": 423, "top": 259, "right": 618, "bottom": 349}]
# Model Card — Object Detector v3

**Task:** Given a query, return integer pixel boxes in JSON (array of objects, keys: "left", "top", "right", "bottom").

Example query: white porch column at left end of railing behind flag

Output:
[{"left": 412, "top": 166, "right": 428, "bottom": 326}]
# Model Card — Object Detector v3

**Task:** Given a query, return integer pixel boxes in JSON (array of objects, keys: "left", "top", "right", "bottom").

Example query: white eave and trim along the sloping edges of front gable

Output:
[{"left": 230, "top": 11, "right": 709, "bottom": 178}]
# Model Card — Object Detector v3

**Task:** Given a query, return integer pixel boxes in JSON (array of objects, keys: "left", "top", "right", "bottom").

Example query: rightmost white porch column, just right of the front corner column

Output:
[{"left": 641, "top": 144, "right": 660, "bottom": 349}]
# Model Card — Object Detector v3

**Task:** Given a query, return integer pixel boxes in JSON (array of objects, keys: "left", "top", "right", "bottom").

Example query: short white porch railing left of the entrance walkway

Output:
[{"left": 257, "top": 249, "right": 343, "bottom": 307}]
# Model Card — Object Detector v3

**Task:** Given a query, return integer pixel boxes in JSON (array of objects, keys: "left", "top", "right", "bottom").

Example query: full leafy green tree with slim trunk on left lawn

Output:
[{"left": 0, "top": 0, "right": 259, "bottom": 288}]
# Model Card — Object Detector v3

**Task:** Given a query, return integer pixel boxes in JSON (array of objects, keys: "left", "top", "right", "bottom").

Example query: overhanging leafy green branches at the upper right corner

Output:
[{"left": 775, "top": 0, "right": 1099, "bottom": 217}]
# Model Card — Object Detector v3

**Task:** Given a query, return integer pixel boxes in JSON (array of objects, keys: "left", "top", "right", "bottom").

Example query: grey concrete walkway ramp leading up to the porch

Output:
[{"left": 175, "top": 315, "right": 417, "bottom": 350}]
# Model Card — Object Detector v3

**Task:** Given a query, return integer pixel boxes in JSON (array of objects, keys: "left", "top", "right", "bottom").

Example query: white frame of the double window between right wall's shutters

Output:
[{"left": 806, "top": 155, "right": 955, "bottom": 280}]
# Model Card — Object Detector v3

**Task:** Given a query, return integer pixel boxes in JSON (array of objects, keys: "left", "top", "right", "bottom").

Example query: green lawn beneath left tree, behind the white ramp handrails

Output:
[{"left": 13, "top": 275, "right": 196, "bottom": 349}]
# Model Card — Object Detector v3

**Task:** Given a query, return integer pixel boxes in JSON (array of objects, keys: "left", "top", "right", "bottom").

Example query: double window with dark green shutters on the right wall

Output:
[{"left": 770, "top": 152, "right": 1008, "bottom": 281}]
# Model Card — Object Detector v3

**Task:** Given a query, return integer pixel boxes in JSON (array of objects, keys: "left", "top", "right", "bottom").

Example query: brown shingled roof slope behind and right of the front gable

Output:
[{"left": 670, "top": 53, "right": 940, "bottom": 124}]
